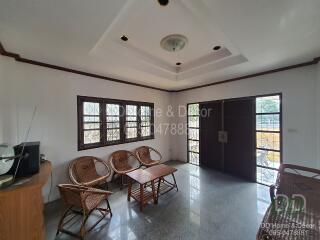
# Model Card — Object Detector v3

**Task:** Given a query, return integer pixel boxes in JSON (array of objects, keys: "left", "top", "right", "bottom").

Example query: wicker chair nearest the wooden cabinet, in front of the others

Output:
[{"left": 56, "top": 184, "right": 112, "bottom": 239}]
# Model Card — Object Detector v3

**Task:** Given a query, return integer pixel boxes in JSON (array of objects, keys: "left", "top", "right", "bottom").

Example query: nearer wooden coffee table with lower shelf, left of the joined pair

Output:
[{"left": 126, "top": 169, "right": 157, "bottom": 211}]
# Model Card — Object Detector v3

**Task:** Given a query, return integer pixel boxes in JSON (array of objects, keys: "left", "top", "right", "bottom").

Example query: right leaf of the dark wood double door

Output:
[{"left": 223, "top": 98, "right": 255, "bottom": 181}]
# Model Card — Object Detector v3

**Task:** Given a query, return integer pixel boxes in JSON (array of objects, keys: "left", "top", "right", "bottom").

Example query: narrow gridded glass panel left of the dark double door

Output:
[{"left": 188, "top": 104, "right": 199, "bottom": 165}]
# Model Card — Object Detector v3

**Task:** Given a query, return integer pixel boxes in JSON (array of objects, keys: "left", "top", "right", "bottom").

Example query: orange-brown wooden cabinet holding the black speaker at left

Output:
[{"left": 0, "top": 161, "right": 52, "bottom": 240}]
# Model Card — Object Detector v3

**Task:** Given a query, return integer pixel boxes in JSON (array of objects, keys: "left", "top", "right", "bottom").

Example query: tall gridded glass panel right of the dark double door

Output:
[{"left": 256, "top": 95, "right": 282, "bottom": 186}]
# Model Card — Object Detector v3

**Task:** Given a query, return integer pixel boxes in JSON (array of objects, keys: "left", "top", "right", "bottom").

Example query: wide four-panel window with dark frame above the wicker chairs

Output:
[{"left": 78, "top": 96, "right": 154, "bottom": 150}]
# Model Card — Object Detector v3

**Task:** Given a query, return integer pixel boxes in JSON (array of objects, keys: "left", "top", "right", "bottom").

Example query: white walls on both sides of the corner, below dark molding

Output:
[{"left": 0, "top": 56, "right": 320, "bottom": 201}]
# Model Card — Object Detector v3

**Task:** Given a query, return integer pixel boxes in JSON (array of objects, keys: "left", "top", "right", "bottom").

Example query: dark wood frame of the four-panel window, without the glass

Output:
[{"left": 77, "top": 96, "right": 154, "bottom": 151}]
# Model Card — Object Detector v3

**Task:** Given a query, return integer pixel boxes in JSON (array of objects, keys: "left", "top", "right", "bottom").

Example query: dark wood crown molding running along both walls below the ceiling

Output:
[{"left": 0, "top": 41, "right": 320, "bottom": 93}]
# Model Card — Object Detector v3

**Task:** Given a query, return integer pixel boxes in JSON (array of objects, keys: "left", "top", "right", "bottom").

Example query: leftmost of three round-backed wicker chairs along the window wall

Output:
[{"left": 69, "top": 156, "right": 111, "bottom": 189}]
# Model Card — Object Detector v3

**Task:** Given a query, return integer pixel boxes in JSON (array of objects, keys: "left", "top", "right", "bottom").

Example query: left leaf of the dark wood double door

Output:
[{"left": 200, "top": 101, "right": 223, "bottom": 171}]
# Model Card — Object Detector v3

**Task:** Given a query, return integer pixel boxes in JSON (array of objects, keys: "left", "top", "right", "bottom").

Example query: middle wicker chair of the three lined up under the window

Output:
[{"left": 109, "top": 150, "right": 139, "bottom": 189}]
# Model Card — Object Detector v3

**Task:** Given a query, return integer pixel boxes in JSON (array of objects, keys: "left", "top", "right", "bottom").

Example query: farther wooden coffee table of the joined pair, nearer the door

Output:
[{"left": 145, "top": 164, "right": 179, "bottom": 201}]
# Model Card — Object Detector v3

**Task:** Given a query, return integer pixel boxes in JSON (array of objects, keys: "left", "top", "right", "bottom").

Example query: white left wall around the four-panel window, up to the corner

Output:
[{"left": 1, "top": 58, "right": 171, "bottom": 201}]
